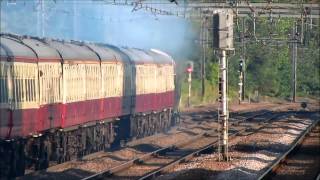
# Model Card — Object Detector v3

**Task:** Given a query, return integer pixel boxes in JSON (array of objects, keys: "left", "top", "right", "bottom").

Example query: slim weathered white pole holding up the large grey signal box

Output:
[{"left": 220, "top": 50, "right": 229, "bottom": 161}]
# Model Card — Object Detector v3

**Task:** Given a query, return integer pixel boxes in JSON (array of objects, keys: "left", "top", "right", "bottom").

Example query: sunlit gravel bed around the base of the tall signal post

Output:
[{"left": 158, "top": 109, "right": 320, "bottom": 180}]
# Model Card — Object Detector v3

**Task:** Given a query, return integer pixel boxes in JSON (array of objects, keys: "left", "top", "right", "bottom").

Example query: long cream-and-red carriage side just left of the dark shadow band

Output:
[{"left": 62, "top": 63, "right": 123, "bottom": 127}]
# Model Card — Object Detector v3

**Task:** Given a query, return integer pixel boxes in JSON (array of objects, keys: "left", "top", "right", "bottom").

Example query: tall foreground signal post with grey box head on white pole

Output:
[{"left": 213, "top": 9, "right": 234, "bottom": 161}]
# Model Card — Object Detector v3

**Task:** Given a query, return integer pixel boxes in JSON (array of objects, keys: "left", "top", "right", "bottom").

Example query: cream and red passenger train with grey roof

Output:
[{"left": 0, "top": 33, "right": 179, "bottom": 177}]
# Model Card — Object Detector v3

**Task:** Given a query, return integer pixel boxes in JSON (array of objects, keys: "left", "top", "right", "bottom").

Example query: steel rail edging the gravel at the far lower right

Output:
[{"left": 258, "top": 120, "right": 320, "bottom": 180}]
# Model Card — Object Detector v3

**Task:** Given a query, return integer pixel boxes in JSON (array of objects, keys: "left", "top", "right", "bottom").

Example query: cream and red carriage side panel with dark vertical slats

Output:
[{"left": 8, "top": 62, "right": 41, "bottom": 137}]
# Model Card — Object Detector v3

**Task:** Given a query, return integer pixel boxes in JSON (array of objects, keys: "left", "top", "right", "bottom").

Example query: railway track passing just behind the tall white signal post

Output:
[{"left": 83, "top": 111, "right": 292, "bottom": 180}]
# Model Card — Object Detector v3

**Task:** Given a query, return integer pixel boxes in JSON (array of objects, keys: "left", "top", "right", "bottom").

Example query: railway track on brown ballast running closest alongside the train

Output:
[{"left": 19, "top": 105, "right": 300, "bottom": 180}]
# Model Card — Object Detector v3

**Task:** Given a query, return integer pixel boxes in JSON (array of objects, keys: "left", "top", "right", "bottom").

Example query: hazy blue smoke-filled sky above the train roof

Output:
[{"left": 0, "top": 0, "right": 195, "bottom": 54}]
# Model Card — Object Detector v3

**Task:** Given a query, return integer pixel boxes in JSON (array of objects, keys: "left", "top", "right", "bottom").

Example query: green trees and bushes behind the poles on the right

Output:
[{"left": 181, "top": 17, "right": 320, "bottom": 106}]
